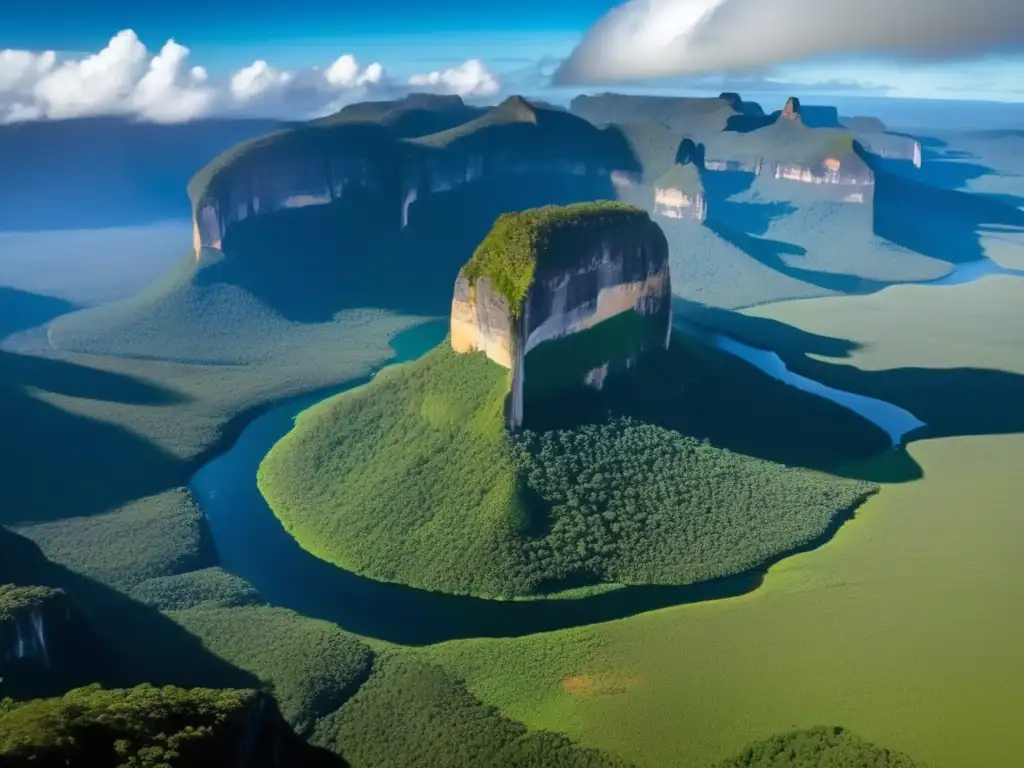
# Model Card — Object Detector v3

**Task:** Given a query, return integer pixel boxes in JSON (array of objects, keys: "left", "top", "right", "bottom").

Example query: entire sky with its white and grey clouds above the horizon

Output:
[{"left": 6, "top": 0, "right": 1024, "bottom": 122}]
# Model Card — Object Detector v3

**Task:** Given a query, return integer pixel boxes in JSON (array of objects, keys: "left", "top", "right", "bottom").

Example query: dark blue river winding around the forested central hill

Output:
[{"left": 191, "top": 263, "right": 1019, "bottom": 645}]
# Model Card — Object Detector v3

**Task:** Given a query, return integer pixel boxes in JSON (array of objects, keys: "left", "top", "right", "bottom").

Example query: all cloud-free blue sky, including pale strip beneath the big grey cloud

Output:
[{"left": 0, "top": 0, "right": 1024, "bottom": 118}]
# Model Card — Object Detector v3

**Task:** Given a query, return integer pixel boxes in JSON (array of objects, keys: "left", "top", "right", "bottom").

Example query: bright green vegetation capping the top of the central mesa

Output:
[{"left": 462, "top": 201, "right": 649, "bottom": 317}]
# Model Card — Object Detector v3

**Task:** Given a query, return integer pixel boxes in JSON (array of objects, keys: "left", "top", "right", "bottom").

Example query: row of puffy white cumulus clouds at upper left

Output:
[{"left": 0, "top": 30, "right": 501, "bottom": 123}]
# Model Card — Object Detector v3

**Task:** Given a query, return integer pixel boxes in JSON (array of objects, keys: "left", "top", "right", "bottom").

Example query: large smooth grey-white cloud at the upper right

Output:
[{"left": 554, "top": 0, "right": 1024, "bottom": 85}]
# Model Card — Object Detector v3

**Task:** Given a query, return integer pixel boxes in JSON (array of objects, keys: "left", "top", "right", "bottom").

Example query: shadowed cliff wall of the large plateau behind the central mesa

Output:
[{"left": 189, "top": 97, "right": 638, "bottom": 256}]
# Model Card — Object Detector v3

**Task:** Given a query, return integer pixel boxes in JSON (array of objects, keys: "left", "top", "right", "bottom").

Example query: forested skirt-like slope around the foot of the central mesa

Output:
[{"left": 258, "top": 336, "right": 888, "bottom": 597}]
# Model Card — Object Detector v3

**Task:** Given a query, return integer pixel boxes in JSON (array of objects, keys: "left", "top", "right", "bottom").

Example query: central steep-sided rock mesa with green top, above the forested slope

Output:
[{"left": 451, "top": 202, "right": 672, "bottom": 430}]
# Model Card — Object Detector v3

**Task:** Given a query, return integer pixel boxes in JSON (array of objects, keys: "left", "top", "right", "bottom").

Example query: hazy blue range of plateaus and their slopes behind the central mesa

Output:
[{"left": 50, "top": 88, "right": 1024, "bottom": 360}]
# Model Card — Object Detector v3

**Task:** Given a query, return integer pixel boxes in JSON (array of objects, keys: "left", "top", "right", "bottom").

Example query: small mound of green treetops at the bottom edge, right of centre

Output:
[{"left": 715, "top": 726, "right": 921, "bottom": 768}]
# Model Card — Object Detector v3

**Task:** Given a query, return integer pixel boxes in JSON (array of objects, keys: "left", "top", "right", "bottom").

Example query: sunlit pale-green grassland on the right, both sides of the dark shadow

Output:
[{"left": 420, "top": 279, "right": 1024, "bottom": 768}]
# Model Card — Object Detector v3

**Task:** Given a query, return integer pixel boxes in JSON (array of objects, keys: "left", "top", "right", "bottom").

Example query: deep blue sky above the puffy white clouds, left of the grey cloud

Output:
[{"left": 0, "top": 0, "right": 598, "bottom": 74}]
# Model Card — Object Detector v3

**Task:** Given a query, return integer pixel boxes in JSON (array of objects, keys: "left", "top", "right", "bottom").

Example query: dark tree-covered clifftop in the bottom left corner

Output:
[{"left": 0, "top": 685, "right": 339, "bottom": 768}]
